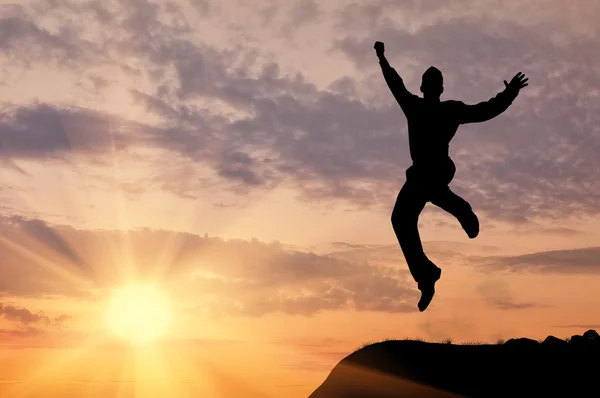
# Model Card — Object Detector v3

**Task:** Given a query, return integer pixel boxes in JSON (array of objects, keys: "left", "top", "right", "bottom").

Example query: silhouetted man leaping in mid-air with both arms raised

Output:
[{"left": 375, "top": 41, "right": 529, "bottom": 311}]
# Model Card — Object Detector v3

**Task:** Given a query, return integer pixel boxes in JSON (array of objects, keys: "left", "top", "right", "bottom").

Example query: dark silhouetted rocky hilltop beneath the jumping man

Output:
[{"left": 309, "top": 330, "right": 600, "bottom": 398}]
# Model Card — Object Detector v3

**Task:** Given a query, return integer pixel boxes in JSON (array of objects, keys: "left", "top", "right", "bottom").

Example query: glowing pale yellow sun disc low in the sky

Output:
[{"left": 106, "top": 284, "right": 172, "bottom": 345}]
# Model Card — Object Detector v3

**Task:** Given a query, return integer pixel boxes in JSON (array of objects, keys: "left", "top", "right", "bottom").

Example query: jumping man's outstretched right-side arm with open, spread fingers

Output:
[{"left": 457, "top": 72, "right": 529, "bottom": 124}]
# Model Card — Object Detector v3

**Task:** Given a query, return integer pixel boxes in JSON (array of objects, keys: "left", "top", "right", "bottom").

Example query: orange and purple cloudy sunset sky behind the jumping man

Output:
[{"left": 0, "top": 0, "right": 600, "bottom": 398}]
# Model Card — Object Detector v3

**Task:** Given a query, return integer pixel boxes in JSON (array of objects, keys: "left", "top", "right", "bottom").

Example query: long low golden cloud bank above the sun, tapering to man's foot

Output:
[{"left": 0, "top": 216, "right": 417, "bottom": 316}]
